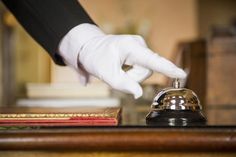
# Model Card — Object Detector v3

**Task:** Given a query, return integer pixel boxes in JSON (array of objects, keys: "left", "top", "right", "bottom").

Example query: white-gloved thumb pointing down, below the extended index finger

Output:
[{"left": 104, "top": 70, "right": 143, "bottom": 99}]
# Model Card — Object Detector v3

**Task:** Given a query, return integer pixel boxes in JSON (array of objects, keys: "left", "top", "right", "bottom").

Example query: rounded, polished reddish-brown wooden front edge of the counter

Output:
[{"left": 0, "top": 127, "right": 236, "bottom": 152}]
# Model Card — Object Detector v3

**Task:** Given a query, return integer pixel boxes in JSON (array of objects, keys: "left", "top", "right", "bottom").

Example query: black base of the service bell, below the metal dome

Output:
[{"left": 146, "top": 110, "right": 206, "bottom": 126}]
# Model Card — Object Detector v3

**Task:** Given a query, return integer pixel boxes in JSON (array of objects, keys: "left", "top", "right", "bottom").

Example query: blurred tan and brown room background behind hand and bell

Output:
[{"left": 0, "top": 0, "right": 236, "bottom": 125}]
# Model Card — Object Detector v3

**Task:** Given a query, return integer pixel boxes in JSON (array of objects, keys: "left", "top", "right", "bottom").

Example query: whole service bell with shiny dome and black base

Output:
[{"left": 146, "top": 79, "right": 206, "bottom": 126}]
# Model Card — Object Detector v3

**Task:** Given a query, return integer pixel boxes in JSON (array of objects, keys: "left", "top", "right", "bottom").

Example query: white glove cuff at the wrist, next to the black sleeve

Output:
[{"left": 58, "top": 23, "right": 105, "bottom": 83}]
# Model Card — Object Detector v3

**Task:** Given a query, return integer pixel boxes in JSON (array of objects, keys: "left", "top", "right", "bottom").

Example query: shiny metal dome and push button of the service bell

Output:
[{"left": 151, "top": 79, "right": 202, "bottom": 111}]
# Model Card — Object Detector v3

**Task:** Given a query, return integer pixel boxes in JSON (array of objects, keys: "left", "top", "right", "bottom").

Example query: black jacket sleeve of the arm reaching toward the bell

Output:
[{"left": 2, "top": 0, "right": 93, "bottom": 65}]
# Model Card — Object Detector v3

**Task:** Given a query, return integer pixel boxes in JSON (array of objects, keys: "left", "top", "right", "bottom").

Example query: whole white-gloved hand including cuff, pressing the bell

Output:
[{"left": 59, "top": 24, "right": 186, "bottom": 98}]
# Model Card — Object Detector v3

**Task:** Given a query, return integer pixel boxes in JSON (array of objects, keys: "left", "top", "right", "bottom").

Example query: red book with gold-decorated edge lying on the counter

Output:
[{"left": 0, "top": 108, "right": 121, "bottom": 126}]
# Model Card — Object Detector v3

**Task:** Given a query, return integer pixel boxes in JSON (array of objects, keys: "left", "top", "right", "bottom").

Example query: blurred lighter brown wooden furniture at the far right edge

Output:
[{"left": 207, "top": 37, "right": 236, "bottom": 106}]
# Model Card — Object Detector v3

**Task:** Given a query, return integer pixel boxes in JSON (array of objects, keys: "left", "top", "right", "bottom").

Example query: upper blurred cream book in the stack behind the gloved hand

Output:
[{"left": 26, "top": 83, "right": 111, "bottom": 98}]
